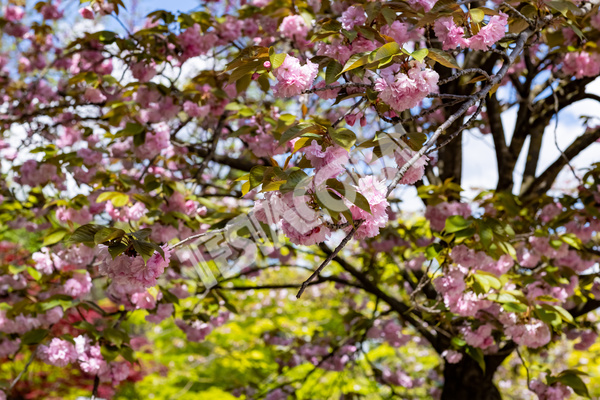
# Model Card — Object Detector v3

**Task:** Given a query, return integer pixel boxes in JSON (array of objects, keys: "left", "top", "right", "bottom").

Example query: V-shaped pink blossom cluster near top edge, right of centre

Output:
[{"left": 433, "top": 13, "right": 508, "bottom": 51}]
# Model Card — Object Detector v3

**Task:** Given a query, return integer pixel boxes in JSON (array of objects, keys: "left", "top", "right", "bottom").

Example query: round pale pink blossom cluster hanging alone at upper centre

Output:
[{"left": 273, "top": 55, "right": 319, "bottom": 97}]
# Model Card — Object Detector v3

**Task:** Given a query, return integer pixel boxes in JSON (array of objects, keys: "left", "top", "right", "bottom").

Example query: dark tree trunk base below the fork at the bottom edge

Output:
[{"left": 441, "top": 355, "right": 502, "bottom": 400}]
